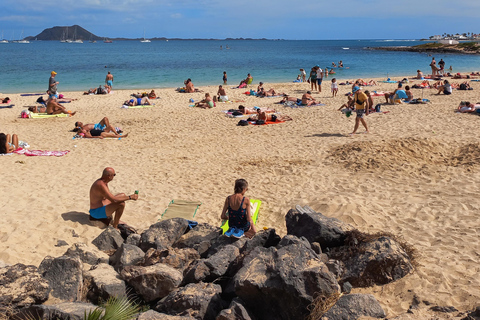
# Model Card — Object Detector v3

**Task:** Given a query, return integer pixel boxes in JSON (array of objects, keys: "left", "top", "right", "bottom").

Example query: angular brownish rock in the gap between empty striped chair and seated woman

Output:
[{"left": 173, "top": 223, "right": 222, "bottom": 256}]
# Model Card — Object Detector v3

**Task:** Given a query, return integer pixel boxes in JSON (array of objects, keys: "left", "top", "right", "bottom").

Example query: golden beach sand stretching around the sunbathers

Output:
[{"left": 0, "top": 76, "right": 480, "bottom": 319}]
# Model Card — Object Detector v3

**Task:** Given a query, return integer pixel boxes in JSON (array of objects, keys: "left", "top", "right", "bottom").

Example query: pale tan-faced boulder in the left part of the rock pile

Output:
[{"left": 83, "top": 263, "right": 126, "bottom": 304}]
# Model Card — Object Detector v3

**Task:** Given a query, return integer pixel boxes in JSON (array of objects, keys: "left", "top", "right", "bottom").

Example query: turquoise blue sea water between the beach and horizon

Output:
[{"left": 0, "top": 40, "right": 480, "bottom": 93}]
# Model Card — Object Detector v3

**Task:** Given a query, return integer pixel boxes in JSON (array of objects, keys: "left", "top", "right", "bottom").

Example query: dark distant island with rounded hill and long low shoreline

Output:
[{"left": 25, "top": 25, "right": 274, "bottom": 42}]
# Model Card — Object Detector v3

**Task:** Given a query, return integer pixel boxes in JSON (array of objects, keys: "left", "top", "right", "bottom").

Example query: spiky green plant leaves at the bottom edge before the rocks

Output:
[{"left": 84, "top": 297, "right": 140, "bottom": 320}]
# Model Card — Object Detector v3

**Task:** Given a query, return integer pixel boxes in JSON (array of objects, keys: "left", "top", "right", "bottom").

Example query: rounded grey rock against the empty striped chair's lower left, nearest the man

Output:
[{"left": 140, "top": 218, "right": 188, "bottom": 251}]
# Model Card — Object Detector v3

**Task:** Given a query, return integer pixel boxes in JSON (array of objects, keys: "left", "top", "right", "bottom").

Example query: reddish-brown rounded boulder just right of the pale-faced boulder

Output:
[{"left": 121, "top": 263, "right": 183, "bottom": 302}]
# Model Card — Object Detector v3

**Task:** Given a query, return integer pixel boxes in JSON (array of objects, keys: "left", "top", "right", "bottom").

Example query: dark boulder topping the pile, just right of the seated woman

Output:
[{"left": 285, "top": 209, "right": 354, "bottom": 250}]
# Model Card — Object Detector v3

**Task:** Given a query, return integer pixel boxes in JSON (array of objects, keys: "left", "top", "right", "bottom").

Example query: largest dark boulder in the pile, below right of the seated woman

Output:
[{"left": 233, "top": 236, "right": 340, "bottom": 320}]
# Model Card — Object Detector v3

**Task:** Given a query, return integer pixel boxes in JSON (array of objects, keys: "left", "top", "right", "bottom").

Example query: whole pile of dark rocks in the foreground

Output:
[{"left": 0, "top": 210, "right": 413, "bottom": 320}]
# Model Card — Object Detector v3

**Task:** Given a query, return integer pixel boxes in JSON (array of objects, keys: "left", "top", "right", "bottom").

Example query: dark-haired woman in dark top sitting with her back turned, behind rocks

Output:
[{"left": 220, "top": 179, "right": 256, "bottom": 238}]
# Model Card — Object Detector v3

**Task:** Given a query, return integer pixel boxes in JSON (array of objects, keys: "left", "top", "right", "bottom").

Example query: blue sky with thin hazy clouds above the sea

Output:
[{"left": 0, "top": 0, "right": 480, "bottom": 40}]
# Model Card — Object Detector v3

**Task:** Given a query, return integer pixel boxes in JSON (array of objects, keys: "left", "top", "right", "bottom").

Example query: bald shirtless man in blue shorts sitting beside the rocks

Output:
[{"left": 89, "top": 167, "right": 138, "bottom": 229}]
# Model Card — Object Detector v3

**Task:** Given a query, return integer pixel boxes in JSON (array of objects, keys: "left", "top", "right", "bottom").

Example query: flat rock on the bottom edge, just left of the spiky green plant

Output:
[{"left": 15, "top": 302, "right": 97, "bottom": 320}]
